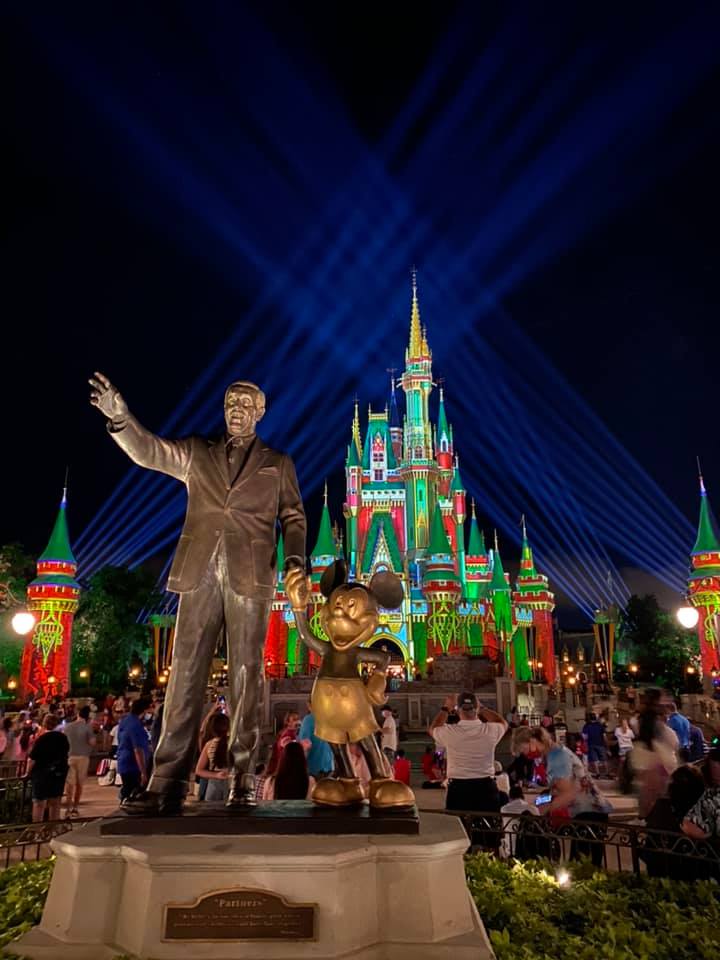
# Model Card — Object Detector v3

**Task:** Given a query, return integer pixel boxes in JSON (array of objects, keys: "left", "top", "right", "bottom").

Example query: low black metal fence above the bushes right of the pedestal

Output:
[{"left": 427, "top": 810, "right": 720, "bottom": 881}]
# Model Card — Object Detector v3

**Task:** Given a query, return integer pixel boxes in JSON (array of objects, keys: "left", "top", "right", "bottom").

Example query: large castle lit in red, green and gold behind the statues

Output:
[{"left": 265, "top": 277, "right": 556, "bottom": 682}]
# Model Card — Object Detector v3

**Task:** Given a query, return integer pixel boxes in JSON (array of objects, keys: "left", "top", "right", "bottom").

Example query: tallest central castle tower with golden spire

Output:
[{"left": 400, "top": 270, "right": 436, "bottom": 561}]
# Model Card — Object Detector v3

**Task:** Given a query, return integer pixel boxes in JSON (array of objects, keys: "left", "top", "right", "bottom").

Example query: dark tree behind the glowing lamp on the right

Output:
[{"left": 622, "top": 594, "right": 699, "bottom": 692}]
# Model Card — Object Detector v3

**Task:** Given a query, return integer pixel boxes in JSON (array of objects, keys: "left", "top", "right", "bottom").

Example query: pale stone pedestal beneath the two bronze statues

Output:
[{"left": 12, "top": 814, "right": 492, "bottom": 960}]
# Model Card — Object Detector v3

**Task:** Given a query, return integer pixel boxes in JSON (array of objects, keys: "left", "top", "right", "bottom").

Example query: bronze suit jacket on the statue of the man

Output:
[{"left": 108, "top": 415, "right": 305, "bottom": 600}]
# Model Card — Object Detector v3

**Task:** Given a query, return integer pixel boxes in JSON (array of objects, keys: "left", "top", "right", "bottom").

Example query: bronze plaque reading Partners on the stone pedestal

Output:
[{"left": 164, "top": 889, "right": 317, "bottom": 940}]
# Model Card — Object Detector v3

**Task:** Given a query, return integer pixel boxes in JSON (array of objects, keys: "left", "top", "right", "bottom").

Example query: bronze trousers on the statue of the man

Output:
[{"left": 148, "top": 544, "right": 272, "bottom": 797}]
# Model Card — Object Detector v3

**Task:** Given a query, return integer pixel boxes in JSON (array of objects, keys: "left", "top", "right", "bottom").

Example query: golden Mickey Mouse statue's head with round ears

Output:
[{"left": 320, "top": 560, "right": 403, "bottom": 650}]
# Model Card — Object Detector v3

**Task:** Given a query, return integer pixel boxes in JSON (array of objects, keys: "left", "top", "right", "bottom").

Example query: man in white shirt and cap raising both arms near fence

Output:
[{"left": 429, "top": 693, "right": 508, "bottom": 811}]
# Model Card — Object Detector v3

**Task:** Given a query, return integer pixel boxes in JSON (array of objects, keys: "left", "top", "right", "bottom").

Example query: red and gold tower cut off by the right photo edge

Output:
[{"left": 688, "top": 474, "right": 720, "bottom": 677}]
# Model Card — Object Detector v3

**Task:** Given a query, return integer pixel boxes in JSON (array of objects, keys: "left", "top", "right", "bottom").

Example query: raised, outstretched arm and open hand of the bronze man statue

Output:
[{"left": 88, "top": 373, "right": 192, "bottom": 481}]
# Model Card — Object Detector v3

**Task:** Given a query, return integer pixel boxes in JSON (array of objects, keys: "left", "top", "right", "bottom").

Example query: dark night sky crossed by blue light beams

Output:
[{"left": 0, "top": 3, "right": 720, "bottom": 624}]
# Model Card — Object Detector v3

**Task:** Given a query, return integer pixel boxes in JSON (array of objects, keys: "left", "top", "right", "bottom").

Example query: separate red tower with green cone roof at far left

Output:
[{"left": 20, "top": 487, "right": 80, "bottom": 703}]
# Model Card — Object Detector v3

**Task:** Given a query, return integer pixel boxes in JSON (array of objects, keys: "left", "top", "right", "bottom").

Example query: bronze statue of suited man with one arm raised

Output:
[{"left": 89, "top": 373, "right": 305, "bottom": 815}]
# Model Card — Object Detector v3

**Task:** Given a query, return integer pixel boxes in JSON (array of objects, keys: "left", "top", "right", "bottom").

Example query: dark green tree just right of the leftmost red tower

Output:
[{"left": 72, "top": 567, "right": 158, "bottom": 690}]
